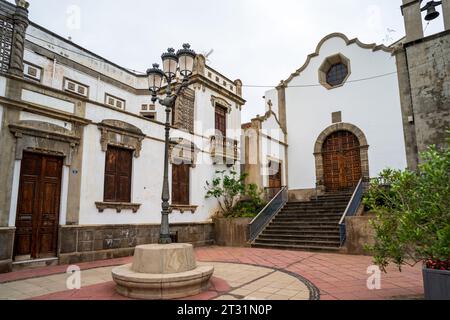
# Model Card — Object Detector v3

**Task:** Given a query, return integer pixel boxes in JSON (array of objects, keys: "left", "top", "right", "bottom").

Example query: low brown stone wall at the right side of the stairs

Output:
[{"left": 345, "top": 214, "right": 375, "bottom": 255}]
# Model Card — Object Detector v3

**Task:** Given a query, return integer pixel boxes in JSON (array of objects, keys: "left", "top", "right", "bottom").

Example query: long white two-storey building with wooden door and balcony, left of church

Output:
[{"left": 0, "top": 1, "right": 245, "bottom": 269}]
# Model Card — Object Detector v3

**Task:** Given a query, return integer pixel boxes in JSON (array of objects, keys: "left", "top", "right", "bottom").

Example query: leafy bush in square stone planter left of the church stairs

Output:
[{"left": 205, "top": 170, "right": 265, "bottom": 246}]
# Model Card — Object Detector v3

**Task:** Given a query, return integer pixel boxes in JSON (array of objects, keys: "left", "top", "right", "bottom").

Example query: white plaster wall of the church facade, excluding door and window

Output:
[{"left": 278, "top": 37, "right": 407, "bottom": 189}]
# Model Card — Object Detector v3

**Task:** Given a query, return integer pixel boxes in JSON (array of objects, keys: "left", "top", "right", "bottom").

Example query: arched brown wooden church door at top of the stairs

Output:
[{"left": 322, "top": 131, "right": 362, "bottom": 192}]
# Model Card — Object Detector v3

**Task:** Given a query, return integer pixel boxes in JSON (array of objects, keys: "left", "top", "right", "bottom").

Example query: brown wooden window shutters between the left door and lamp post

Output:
[{"left": 104, "top": 146, "right": 133, "bottom": 202}]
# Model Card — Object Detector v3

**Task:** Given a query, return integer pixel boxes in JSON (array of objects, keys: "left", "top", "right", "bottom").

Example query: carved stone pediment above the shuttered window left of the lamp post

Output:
[{"left": 98, "top": 120, "right": 145, "bottom": 158}]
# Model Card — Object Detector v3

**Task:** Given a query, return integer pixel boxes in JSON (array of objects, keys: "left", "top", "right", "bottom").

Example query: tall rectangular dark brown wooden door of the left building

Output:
[{"left": 14, "top": 152, "right": 63, "bottom": 259}]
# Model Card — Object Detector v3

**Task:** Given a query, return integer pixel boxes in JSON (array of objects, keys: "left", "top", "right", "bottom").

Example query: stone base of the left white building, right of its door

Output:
[{"left": 59, "top": 223, "right": 214, "bottom": 264}]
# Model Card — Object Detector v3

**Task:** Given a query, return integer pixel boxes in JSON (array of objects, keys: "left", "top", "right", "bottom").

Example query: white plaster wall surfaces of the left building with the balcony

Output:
[{"left": 14, "top": 26, "right": 241, "bottom": 225}]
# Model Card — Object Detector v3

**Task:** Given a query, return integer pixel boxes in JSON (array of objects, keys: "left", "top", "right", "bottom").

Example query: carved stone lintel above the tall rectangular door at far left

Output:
[{"left": 9, "top": 120, "right": 81, "bottom": 167}]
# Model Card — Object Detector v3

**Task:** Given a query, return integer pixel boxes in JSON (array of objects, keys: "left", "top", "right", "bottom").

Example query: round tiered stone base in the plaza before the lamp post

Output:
[{"left": 112, "top": 243, "right": 214, "bottom": 300}]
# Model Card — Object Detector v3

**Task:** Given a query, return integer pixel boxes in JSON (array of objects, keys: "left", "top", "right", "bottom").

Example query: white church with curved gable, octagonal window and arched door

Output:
[{"left": 253, "top": 33, "right": 407, "bottom": 198}]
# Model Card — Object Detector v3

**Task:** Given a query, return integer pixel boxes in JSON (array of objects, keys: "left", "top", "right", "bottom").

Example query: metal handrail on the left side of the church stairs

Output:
[{"left": 249, "top": 187, "right": 288, "bottom": 242}]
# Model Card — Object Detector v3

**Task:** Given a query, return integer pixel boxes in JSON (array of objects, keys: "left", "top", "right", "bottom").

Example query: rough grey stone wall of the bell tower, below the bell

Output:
[{"left": 397, "top": 30, "right": 450, "bottom": 169}]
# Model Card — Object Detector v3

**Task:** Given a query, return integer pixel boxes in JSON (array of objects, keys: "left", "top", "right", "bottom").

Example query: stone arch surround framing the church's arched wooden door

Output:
[{"left": 314, "top": 123, "right": 370, "bottom": 192}]
